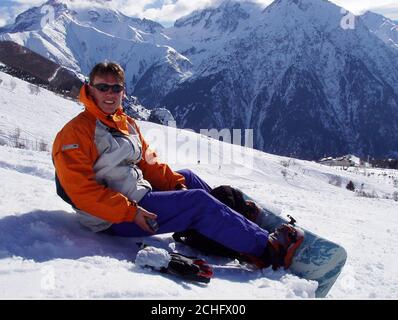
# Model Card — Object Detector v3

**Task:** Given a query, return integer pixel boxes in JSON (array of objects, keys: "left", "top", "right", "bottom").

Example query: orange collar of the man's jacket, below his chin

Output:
[{"left": 79, "top": 84, "right": 129, "bottom": 134}]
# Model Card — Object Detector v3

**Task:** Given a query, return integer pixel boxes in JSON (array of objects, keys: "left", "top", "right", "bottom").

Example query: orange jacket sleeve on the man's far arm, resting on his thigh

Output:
[{"left": 130, "top": 120, "right": 185, "bottom": 191}]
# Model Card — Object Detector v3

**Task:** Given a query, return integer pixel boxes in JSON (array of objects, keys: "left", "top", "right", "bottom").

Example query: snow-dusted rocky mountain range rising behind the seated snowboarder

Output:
[{"left": 0, "top": 0, "right": 398, "bottom": 159}]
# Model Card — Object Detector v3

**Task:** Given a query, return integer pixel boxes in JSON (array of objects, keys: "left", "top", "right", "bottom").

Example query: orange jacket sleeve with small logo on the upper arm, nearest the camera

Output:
[{"left": 53, "top": 121, "right": 136, "bottom": 223}]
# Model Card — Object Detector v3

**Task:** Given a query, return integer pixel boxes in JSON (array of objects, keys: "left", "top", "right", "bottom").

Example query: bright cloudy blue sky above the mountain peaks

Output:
[{"left": 0, "top": 0, "right": 398, "bottom": 26}]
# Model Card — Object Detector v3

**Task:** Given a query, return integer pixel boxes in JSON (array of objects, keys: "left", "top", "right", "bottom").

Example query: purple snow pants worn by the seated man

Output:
[{"left": 107, "top": 170, "right": 268, "bottom": 257}]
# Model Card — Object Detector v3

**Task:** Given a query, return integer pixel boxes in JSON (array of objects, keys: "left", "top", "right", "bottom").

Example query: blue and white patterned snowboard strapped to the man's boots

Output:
[{"left": 243, "top": 193, "right": 347, "bottom": 298}]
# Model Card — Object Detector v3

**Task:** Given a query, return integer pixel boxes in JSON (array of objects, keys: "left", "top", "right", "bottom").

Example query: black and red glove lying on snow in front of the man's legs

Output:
[{"left": 162, "top": 252, "right": 213, "bottom": 283}]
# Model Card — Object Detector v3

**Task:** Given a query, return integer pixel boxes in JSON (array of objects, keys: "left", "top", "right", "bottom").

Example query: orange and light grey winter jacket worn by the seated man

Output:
[{"left": 52, "top": 85, "right": 185, "bottom": 232}]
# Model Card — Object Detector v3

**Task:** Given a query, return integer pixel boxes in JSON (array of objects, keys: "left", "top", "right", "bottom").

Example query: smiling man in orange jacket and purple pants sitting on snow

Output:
[{"left": 52, "top": 62, "right": 303, "bottom": 280}]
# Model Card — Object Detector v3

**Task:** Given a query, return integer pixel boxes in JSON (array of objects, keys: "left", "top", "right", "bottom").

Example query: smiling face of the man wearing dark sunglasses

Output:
[{"left": 89, "top": 74, "right": 124, "bottom": 114}]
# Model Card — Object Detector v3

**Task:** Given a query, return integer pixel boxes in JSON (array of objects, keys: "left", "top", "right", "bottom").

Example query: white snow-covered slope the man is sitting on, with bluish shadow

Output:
[{"left": 0, "top": 73, "right": 398, "bottom": 299}]
